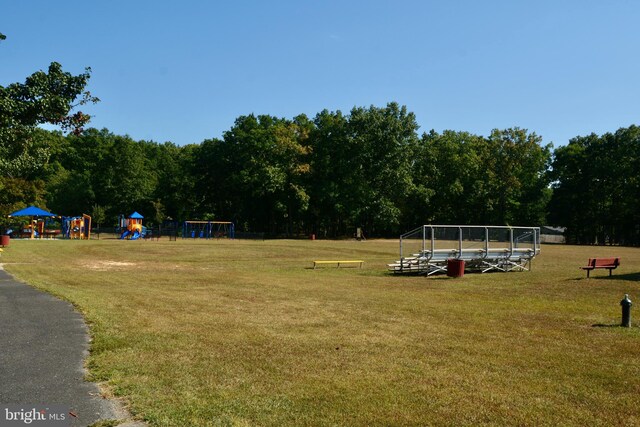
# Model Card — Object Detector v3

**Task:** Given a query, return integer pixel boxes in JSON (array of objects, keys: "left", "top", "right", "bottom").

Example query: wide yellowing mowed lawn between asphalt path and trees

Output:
[{"left": 0, "top": 240, "right": 640, "bottom": 426}]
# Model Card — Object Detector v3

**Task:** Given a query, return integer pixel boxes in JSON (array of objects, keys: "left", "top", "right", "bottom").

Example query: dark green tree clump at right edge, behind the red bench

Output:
[{"left": 549, "top": 126, "right": 640, "bottom": 245}]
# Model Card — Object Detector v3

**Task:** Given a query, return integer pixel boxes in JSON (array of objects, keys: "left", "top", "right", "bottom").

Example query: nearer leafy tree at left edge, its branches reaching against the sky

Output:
[{"left": 0, "top": 33, "right": 98, "bottom": 221}]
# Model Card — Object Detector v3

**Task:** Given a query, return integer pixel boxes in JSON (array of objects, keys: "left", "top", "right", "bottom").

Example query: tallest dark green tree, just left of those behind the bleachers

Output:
[{"left": 310, "top": 103, "right": 418, "bottom": 235}]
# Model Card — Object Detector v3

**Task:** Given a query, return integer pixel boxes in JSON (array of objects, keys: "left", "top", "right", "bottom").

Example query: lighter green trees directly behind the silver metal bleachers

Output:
[{"left": 416, "top": 128, "right": 551, "bottom": 225}]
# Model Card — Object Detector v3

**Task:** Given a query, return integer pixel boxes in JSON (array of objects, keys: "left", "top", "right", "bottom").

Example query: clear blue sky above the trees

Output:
[{"left": 0, "top": 0, "right": 640, "bottom": 146}]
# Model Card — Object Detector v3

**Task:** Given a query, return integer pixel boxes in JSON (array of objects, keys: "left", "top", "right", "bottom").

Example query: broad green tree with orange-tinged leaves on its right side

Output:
[{"left": 196, "top": 115, "right": 309, "bottom": 234}]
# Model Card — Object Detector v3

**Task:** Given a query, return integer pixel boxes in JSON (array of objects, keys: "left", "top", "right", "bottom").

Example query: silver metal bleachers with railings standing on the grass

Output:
[{"left": 389, "top": 225, "right": 540, "bottom": 276}]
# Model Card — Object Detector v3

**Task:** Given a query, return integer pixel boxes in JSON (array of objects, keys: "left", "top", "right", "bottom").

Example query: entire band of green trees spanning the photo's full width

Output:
[{"left": 0, "top": 57, "right": 640, "bottom": 245}]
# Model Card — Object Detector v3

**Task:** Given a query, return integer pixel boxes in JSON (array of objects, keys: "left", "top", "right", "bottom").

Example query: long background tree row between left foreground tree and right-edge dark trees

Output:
[{"left": 5, "top": 103, "right": 551, "bottom": 237}]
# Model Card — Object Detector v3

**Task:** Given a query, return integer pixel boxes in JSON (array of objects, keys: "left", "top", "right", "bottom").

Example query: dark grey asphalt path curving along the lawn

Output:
[{"left": 0, "top": 266, "right": 138, "bottom": 426}]
